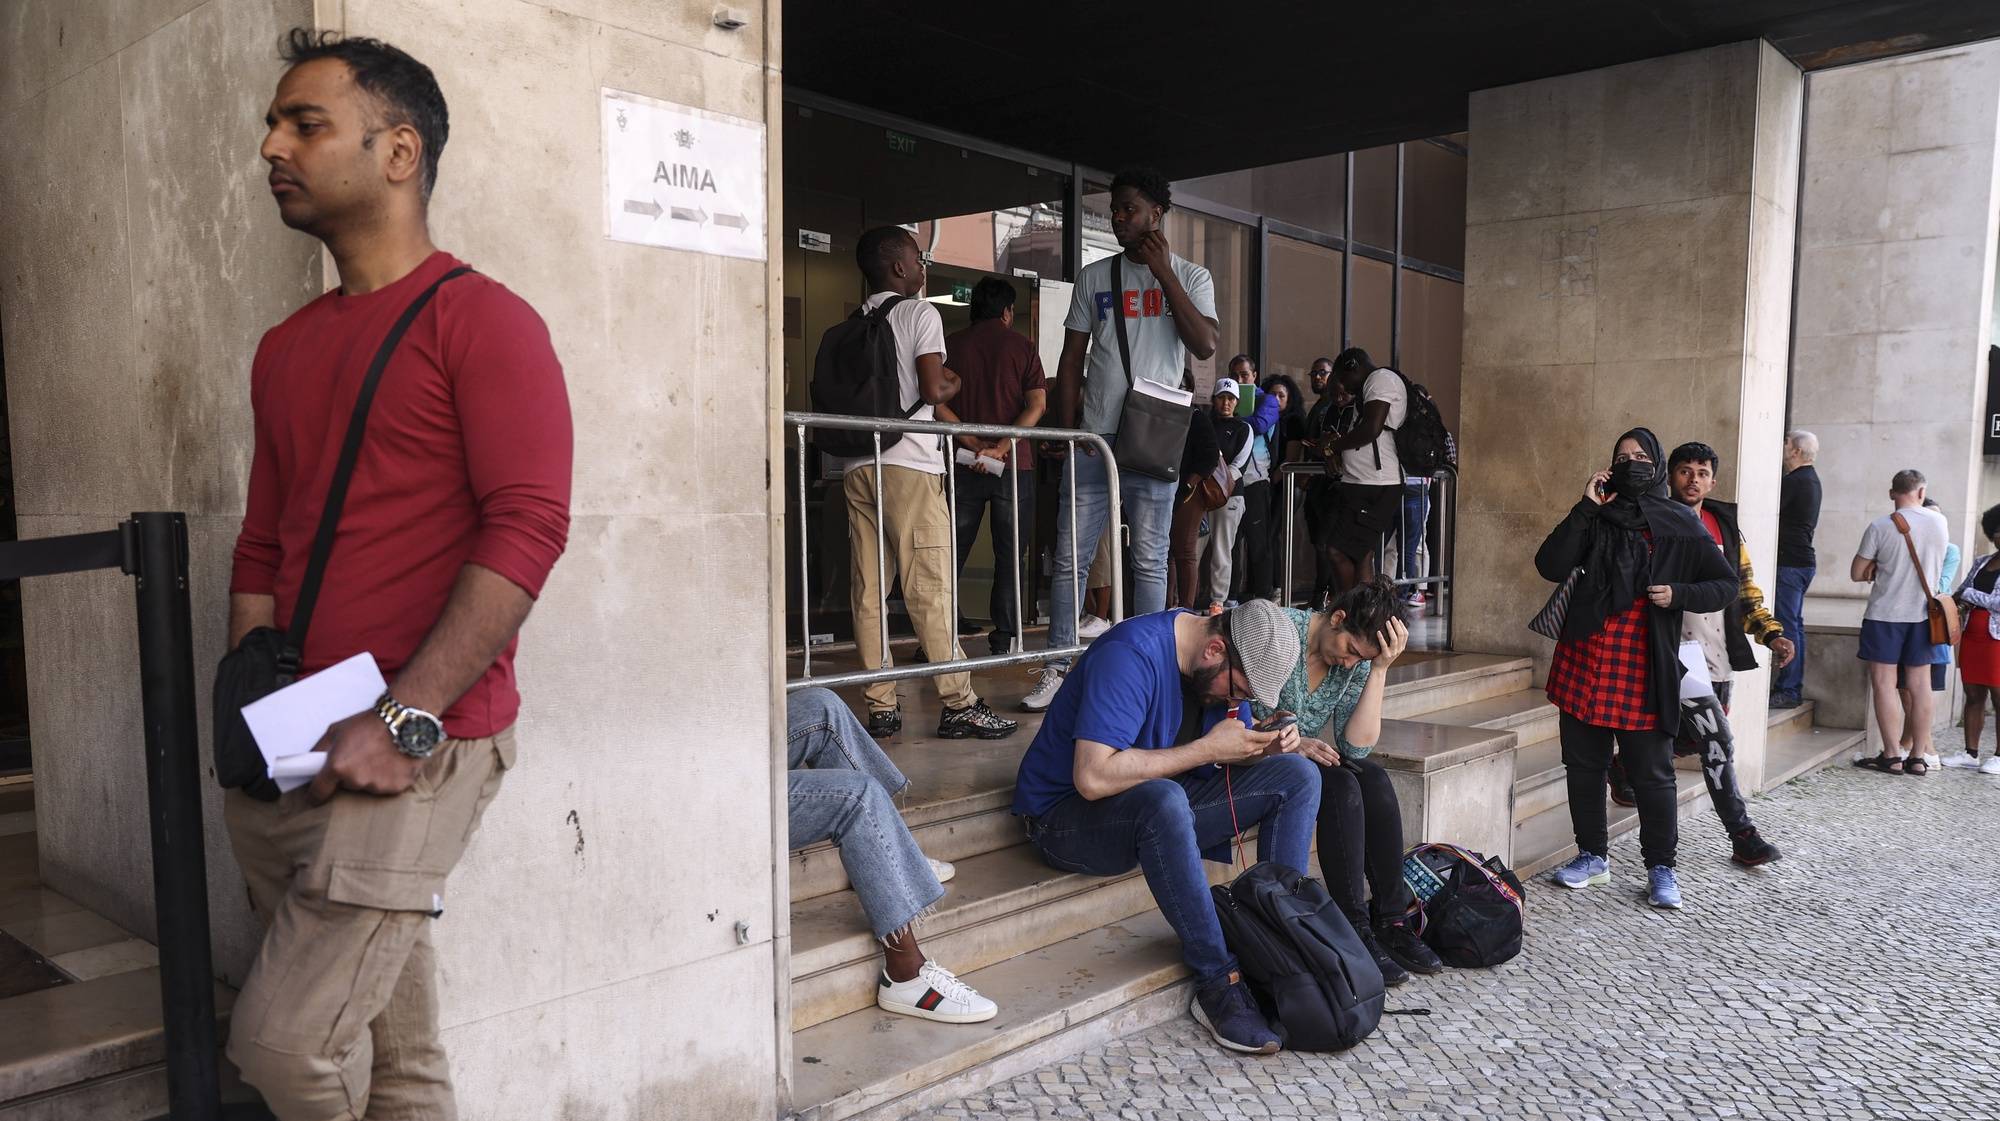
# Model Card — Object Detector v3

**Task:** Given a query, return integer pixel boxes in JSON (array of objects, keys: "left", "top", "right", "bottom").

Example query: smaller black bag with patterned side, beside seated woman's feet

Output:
[{"left": 1402, "top": 845, "right": 1526, "bottom": 969}]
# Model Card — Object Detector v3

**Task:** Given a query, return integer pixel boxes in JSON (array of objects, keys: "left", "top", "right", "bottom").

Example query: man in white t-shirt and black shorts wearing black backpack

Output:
[{"left": 1320, "top": 346, "right": 1410, "bottom": 595}]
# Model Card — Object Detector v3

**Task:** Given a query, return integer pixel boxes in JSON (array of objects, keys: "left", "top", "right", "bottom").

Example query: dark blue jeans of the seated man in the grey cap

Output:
[{"left": 1028, "top": 749, "right": 1320, "bottom": 985}]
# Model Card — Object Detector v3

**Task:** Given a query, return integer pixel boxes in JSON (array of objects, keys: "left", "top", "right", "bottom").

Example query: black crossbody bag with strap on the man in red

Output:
[{"left": 214, "top": 266, "right": 472, "bottom": 803}]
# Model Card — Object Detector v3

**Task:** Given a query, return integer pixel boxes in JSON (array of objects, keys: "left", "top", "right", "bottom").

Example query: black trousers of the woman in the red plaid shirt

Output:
[{"left": 1562, "top": 713, "right": 1680, "bottom": 867}]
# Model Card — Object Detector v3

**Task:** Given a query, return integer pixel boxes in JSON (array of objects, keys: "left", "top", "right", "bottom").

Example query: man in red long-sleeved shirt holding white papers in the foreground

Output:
[{"left": 226, "top": 30, "right": 572, "bottom": 1121}]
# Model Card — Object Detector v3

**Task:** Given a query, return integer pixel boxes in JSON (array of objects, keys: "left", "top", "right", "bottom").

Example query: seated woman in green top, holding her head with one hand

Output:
[{"left": 1254, "top": 577, "right": 1444, "bottom": 985}]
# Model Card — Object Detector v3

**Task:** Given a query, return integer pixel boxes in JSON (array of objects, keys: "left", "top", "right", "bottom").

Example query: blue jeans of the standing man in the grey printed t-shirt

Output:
[{"left": 1048, "top": 438, "right": 1178, "bottom": 669}]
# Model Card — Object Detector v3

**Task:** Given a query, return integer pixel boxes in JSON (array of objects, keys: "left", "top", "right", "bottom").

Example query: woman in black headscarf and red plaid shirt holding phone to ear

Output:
[{"left": 1534, "top": 428, "right": 1736, "bottom": 909}]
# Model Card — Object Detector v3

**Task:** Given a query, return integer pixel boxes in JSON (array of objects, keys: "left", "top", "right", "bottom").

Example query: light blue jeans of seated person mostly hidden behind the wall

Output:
[{"left": 784, "top": 689, "right": 944, "bottom": 939}]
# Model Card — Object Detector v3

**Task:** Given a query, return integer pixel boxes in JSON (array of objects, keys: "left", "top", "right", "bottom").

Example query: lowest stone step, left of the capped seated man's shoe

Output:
[{"left": 792, "top": 911, "right": 1190, "bottom": 1121}]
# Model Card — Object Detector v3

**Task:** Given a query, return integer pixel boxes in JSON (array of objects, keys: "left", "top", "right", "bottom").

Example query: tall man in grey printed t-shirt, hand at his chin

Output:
[{"left": 1022, "top": 168, "right": 1216, "bottom": 713}]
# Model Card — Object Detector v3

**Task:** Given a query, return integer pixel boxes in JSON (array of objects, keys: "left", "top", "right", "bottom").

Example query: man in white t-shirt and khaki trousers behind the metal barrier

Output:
[{"left": 842, "top": 226, "right": 1016, "bottom": 739}]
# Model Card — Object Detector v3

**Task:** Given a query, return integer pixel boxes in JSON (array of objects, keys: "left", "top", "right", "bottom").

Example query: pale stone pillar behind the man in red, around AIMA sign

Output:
[{"left": 0, "top": 0, "right": 790, "bottom": 1121}]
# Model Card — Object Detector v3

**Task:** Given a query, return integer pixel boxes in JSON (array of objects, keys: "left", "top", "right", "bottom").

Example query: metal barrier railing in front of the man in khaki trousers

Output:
[{"left": 784, "top": 412, "right": 1124, "bottom": 693}]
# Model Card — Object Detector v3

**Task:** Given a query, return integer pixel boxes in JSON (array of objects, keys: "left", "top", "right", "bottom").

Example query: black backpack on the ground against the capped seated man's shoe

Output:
[{"left": 1208, "top": 861, "right": 1382, "bottom": 1051}]
